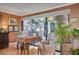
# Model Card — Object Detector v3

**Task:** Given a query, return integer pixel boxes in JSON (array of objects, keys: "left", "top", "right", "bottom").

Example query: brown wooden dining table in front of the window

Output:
[{"left": 17, "top": 36, "right": 41, "bottom": 55}]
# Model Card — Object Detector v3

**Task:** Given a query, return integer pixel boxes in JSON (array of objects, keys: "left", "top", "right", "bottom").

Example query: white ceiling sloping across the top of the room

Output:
[{"left": 0, "top": 3, "right": 73, "bottom": 16}]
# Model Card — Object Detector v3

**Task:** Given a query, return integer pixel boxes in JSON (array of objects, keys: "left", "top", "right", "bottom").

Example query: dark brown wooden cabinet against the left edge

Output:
[{"left": 0, "top": 32, "right": 9, "bottom": 49}]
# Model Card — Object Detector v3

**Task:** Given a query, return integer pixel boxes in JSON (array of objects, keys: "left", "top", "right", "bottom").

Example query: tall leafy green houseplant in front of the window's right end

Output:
[{"left": 54, "top": 25, "right": 72, "bottom": 54}]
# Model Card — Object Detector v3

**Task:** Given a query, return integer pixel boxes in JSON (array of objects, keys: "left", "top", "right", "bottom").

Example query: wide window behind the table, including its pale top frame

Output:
[{"left": 23, "top": 10, "right": 69, "bottom": 40}]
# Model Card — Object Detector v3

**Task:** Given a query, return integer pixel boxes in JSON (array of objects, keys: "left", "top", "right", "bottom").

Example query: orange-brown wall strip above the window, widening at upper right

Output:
[{"left": 22, "top": 3, "right": 79, "bottom": 18}]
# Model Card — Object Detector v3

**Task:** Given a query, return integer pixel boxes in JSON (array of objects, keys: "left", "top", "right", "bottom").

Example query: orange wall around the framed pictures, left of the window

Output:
[{"left": 0, "top": 12, "right": 21, "bottom": 43}]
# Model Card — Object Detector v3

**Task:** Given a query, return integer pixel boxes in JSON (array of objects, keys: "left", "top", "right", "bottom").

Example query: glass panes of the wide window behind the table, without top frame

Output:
[{"left": 23, "top": 16, "right": 55, "bottom": 40}]
